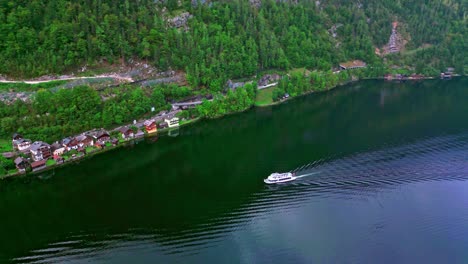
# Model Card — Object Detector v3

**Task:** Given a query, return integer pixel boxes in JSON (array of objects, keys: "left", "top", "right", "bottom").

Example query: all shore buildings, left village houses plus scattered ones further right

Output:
[{"left": 3, "top": 56, "right": 453, "bottom": 176}]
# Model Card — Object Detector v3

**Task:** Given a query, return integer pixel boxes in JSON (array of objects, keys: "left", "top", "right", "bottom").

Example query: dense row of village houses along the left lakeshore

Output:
[{"left": 10, "top": 110, "right": 183, "bottom": 175}]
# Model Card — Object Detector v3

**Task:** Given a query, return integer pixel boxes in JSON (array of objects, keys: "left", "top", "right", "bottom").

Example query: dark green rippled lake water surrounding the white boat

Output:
[{"left": 0, "top": 78, "right": 468, "bottom": 263}]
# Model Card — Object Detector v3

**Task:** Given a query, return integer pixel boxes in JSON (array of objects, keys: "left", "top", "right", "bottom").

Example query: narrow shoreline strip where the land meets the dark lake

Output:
[{"left": 0, "top": 77, "right": 454, "bottom": 180}]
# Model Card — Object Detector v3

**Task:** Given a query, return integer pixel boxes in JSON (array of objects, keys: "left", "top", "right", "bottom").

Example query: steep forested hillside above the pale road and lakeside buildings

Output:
[{"left": 0, "top": 0, "right": 468, "bottom": 82}]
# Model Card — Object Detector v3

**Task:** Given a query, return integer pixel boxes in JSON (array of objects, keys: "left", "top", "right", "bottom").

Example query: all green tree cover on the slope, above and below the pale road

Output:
[{"left": 0, "top": 0, "right": 468, "bottom": 148}]
